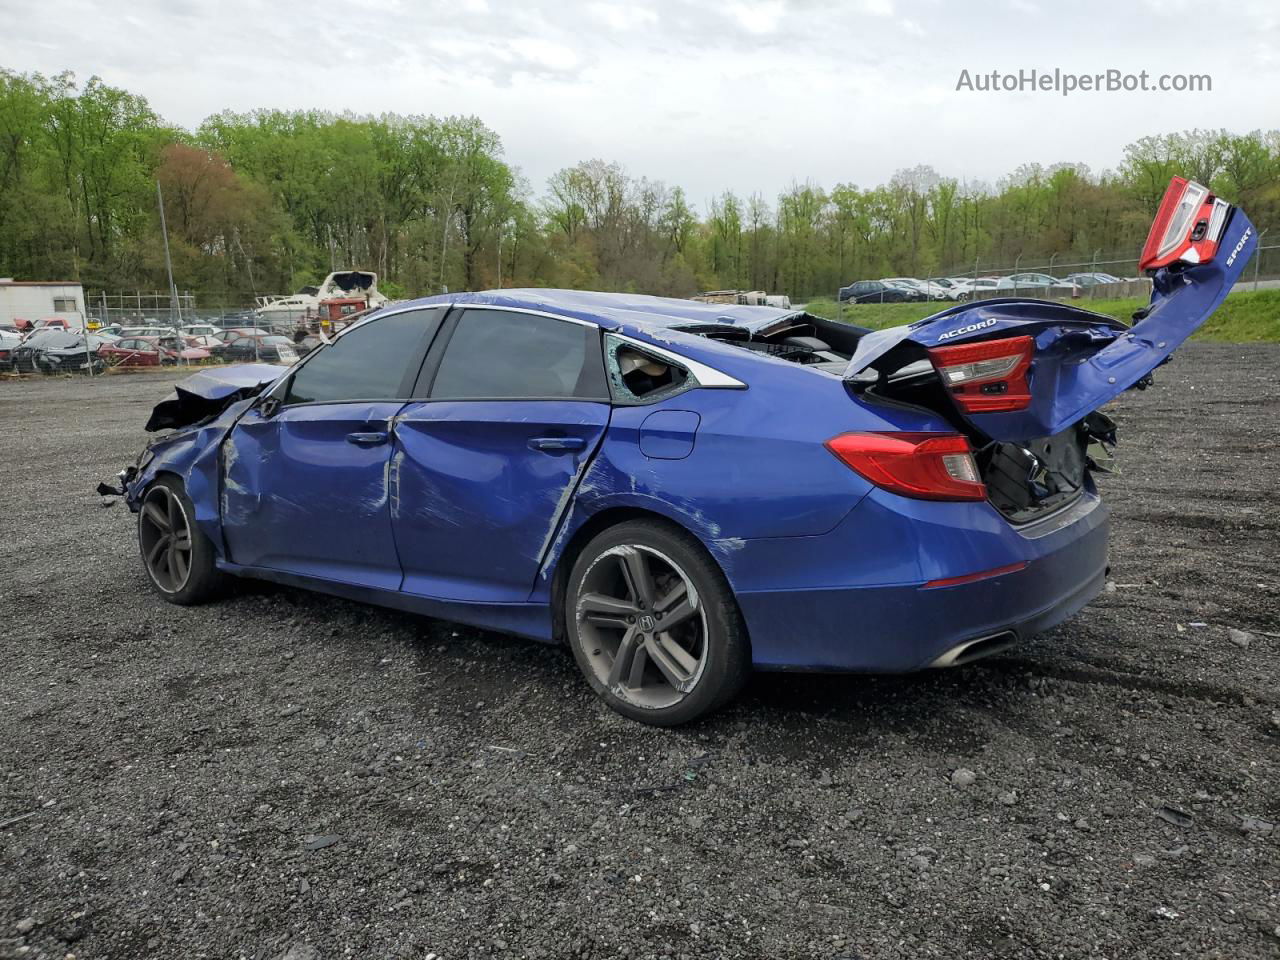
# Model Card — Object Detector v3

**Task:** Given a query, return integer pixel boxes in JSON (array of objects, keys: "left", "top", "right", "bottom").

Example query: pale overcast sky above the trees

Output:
[{"left": 0, "top": 0, "right": 1280, "bottom": 207}]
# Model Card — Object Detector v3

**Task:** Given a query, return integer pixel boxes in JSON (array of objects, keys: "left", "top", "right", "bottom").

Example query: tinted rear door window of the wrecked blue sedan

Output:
[{"left": 431, "top": 310, "right": 609, "bottom": 399}]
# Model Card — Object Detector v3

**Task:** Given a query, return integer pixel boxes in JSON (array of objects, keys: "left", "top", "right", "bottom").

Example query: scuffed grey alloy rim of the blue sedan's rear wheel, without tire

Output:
[{"left": 573, "top": 544, "right": 708, "bottom": 709}]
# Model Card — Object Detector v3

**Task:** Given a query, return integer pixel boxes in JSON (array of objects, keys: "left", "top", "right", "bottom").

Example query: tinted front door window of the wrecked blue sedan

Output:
[{"left": 286, "top": 308, "right": 442, "bottom": 403}]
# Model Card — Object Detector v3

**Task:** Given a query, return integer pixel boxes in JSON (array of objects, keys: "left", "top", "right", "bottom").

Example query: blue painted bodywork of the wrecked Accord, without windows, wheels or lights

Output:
[{"left": 128, "top": 211, "right": 1252, "bottom": 671}]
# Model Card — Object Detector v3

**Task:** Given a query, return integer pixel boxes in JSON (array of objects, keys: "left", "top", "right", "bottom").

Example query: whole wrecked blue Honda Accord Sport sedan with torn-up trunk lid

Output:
[{"left": 99, "top": 179, "right": 1256, "bottom": 724}]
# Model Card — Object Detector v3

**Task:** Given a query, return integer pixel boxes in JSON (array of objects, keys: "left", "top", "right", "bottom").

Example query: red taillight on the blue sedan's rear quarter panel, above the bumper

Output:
[{"left": 827, "top": 433, "right": 987, "bottom": 500}]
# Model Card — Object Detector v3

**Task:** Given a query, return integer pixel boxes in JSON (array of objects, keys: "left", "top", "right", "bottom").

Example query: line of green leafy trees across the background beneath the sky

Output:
[{"left": 0, "top": 69, "right": 1280, "bottom": 303}]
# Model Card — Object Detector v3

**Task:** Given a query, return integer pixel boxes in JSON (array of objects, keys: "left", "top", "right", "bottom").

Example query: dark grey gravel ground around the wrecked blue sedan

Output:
[{"left": 0, "top": 344, "right": 1280, "bottom": 960}]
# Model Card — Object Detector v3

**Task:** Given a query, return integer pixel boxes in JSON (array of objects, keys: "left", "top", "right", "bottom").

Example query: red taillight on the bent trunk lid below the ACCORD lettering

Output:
[{"left": 929, "top": 337, "right": 1036, "bottom": 413}]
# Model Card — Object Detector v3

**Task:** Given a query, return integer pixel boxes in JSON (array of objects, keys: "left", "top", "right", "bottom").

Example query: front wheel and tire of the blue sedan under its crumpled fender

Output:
[{"left": 138, "top": 476, "right": 228, "bottom": 607}]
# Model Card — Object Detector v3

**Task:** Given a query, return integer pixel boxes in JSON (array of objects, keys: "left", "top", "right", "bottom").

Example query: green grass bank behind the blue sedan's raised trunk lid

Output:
[{"left": 805, "top": 289, "right": 1280, "bottom": 343}]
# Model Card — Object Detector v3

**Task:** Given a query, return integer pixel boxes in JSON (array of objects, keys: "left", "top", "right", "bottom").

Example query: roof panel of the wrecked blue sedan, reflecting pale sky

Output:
[{"left": 413, "top": 288, "right": 803, "bottom": 330}]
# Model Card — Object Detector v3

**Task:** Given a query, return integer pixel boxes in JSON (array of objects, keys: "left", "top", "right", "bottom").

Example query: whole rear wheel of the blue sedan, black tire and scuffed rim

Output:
[{"left": 564, "top": 520, "right": 750, "bottom": 727}]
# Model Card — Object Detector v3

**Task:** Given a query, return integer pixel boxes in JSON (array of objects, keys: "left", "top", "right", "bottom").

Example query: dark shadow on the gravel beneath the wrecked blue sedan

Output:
[{"left": 222, "top": 581, "right": 1039, "bottom": 759}]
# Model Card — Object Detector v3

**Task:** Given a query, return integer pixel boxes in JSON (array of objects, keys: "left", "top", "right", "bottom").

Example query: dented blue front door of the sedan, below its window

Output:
[{"left": 223, "top": 401, "right": 404, "bottom": 590}]
